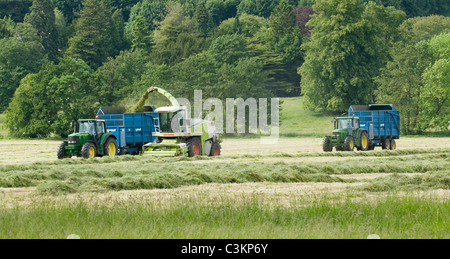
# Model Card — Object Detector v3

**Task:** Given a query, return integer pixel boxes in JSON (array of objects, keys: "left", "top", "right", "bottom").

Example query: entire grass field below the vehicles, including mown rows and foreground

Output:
[{"left": 0, "top": 138, "right": 450, "bottom": 239}]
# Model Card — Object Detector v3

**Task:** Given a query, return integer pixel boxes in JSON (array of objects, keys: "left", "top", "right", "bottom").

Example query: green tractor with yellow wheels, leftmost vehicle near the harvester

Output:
[{"left": 57, "top": 120, "right": 117, "bottom": 159}]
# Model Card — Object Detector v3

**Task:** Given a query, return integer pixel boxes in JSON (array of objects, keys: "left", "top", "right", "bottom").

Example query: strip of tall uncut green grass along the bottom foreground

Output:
[{"left": 0, "top": 194, "right": 450, "bottom": 239}]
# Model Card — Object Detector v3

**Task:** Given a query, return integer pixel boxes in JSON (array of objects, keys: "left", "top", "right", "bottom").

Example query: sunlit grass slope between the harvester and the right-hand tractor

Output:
[{"left": 280, "top": 97, "right": 333, "bottom": 137}]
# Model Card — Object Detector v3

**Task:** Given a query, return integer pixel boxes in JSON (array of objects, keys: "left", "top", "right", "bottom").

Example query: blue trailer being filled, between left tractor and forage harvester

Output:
[{"left": 97, "top": 106, "right": 159, "bottom": 155}]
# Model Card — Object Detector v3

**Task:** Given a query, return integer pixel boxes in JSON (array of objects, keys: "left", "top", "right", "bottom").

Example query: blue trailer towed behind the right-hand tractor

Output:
[{"left": 348, "top": 104, "right": 400, "bottom": 149}]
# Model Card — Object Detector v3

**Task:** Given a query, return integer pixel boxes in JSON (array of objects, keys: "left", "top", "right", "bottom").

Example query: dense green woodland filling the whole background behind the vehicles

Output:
[{"left": 0, "top": 0, "right": 450, "bottom": 137}]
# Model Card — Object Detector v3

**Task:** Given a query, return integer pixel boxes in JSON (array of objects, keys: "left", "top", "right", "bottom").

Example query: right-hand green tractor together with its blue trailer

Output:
[{"left": 323, "top": 104, "right": 400, "bottom": 152}]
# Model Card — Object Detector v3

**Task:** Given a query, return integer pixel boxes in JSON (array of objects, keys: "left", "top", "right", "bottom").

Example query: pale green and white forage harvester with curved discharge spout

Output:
[{"left": 142, "top": 87, "right": 221, "bottom": 157}]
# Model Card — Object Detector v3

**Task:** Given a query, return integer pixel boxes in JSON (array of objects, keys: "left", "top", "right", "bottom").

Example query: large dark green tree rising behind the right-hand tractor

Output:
[{"left": 299, "top": 0, "right": 404, "bottom": 112}]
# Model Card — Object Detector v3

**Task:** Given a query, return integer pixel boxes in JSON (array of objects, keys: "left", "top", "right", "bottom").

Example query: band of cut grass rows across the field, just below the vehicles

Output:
[{"left": 0, "top": 149, "right": 450, "bottom": 194}]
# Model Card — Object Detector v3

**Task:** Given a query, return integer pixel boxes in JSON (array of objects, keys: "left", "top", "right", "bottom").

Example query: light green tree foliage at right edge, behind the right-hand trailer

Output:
[{"left": 376, "top": 16, "right": 450, "bottom": 134}]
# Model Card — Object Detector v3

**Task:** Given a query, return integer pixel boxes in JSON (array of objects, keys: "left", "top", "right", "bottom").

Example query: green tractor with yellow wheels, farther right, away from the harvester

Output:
[{"left": 323, "top": 117, "right": 373, "bottom": 152}]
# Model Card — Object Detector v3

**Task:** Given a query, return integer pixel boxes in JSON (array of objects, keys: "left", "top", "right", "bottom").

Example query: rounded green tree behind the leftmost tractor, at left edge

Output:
[{"left": 6, "top": 57, "right": 97, "bottom": 137}]
